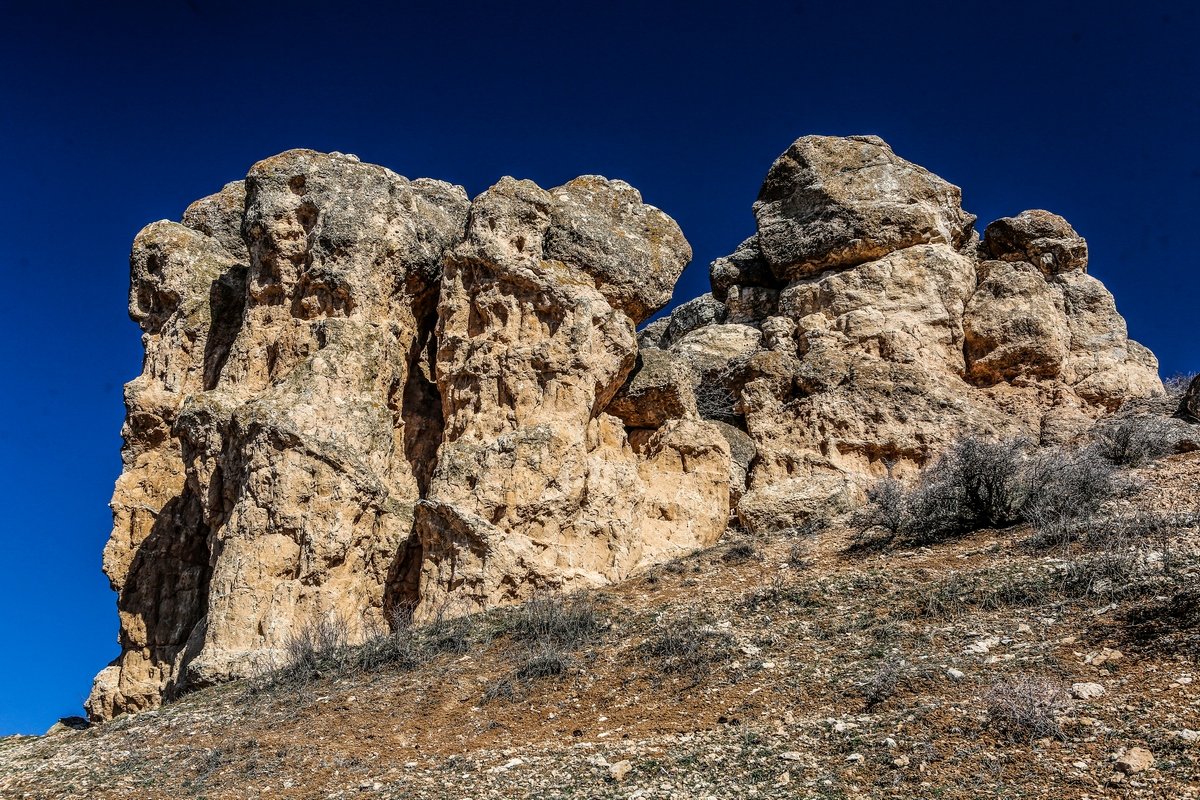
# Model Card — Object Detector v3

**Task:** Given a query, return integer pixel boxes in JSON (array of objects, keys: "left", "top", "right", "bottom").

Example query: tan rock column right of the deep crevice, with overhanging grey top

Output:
[{"left": 416, "top": 178, "right": 728, "bottom": 616}]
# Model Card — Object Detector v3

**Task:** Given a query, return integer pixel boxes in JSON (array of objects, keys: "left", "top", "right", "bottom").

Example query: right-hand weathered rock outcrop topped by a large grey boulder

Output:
[{"left": 662, "top": 137, "right": 1163, "bottom": 530}]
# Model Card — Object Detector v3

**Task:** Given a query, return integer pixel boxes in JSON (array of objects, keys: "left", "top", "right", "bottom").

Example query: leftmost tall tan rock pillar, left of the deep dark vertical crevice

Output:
[{"left": 89, "top": 151, "right": 468, "bottom": 718}]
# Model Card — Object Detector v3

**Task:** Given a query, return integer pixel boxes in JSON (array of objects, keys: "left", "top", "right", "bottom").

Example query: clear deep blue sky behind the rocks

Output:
[{"left": 0, "top": 0, "right": 1200, "bottom": 734}]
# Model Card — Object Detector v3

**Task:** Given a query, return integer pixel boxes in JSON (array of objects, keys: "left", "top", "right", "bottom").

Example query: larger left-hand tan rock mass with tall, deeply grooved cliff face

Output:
[{"left": 88, "top": 150, "right": 730, "bottom": 720}]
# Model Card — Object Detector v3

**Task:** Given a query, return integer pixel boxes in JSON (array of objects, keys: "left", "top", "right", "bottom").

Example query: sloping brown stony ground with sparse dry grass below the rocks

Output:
[{"left": 9, "top": 453, "right": 1200, "bottom": 800}]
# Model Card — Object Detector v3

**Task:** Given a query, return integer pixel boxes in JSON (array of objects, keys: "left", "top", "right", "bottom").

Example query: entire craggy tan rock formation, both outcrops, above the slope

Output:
[{"left": 88, "top": 137, "right": 1162, "bottom": 720}]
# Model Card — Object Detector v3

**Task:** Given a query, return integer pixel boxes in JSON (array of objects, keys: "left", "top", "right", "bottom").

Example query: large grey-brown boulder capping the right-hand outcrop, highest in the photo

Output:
[{"left": 754, "top": 136, "right": 974, "bottom": 279}]
